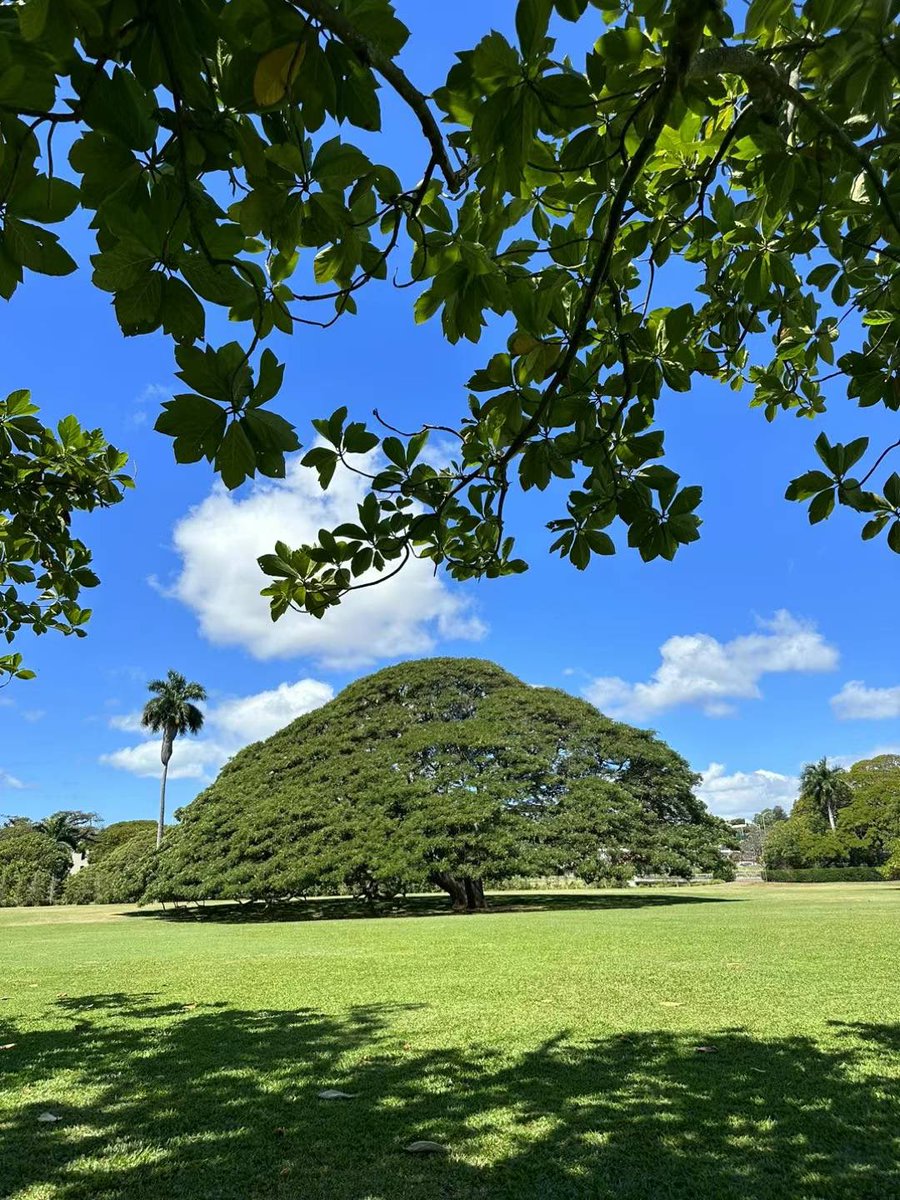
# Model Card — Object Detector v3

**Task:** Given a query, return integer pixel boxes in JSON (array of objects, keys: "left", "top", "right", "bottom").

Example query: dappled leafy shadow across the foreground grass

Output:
[{"left": 0, "top": 995, "right": 900, "bottom": 1200}]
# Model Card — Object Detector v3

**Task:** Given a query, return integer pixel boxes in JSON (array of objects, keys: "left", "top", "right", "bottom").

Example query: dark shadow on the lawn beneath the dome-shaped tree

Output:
[{"left": 122, "top": 888, "right": 746, "bottom": 924}]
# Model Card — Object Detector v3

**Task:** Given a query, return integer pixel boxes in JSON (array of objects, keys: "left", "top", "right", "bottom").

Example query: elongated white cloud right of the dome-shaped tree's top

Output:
[{"left": 584, "top": 610, "right": 838, "bottom": 720}]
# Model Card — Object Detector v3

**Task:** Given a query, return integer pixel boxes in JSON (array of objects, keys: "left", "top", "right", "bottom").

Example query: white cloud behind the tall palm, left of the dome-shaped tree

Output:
[{"left": 100, "top": 679, "right": 334, "bottom": 779}]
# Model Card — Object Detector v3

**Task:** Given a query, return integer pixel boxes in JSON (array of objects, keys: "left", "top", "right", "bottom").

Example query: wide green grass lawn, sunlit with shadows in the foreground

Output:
[{"left": 0, "top": 884, "right": 900, "bottom": 1200}]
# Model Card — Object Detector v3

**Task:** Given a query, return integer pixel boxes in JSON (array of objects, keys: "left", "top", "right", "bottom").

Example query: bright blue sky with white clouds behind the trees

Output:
[{"left": 0, "top": 0, "right": 900, "bottom": 821}]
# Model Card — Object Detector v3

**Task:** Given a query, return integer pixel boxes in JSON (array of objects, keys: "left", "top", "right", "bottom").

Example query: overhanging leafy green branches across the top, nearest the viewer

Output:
[{"left": 0, "top": 0, "right": 900, "bottom": 676}]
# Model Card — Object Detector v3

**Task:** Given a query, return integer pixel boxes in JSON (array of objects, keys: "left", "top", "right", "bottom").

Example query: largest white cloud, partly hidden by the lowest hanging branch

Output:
[{"left": 167, "top": 458, "right": 486, "bottom": 667}]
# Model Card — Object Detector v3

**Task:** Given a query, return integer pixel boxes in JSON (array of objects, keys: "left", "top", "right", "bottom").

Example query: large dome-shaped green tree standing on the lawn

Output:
[{"left": 155, "top": 659, "right": 726, "bottom": 910}]
